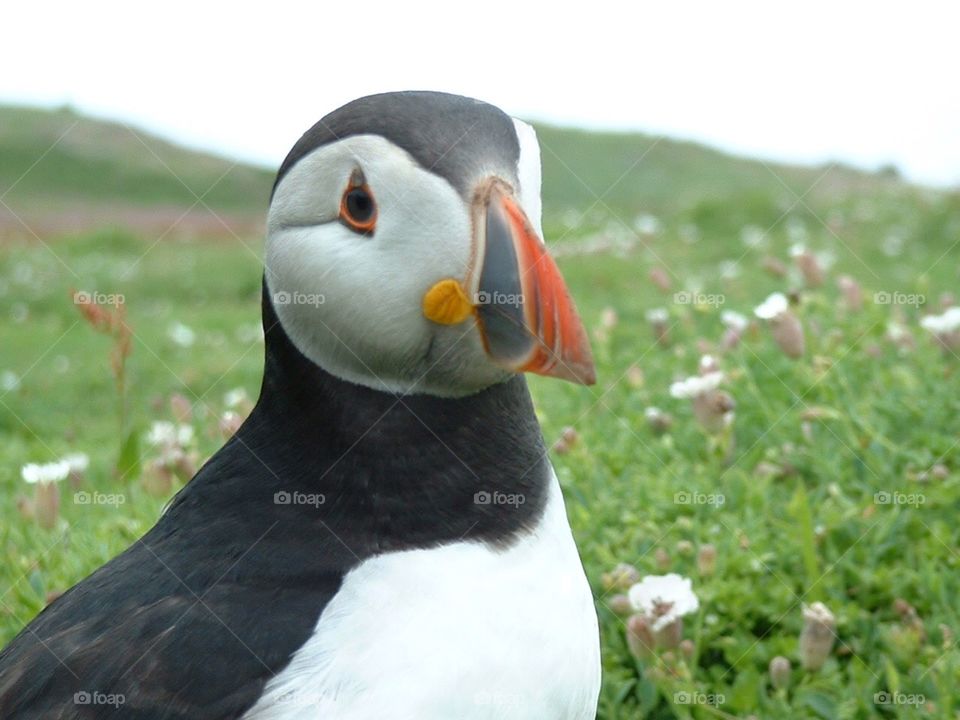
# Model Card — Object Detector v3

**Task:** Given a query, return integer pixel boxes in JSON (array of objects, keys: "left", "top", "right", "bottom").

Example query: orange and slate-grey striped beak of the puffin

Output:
[{"left": 468, "top": 179, "right": 596, "bottom": 385}]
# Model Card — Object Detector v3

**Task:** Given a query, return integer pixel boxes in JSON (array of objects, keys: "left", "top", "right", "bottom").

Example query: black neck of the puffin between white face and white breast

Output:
[{"left": 213, "top": 282, "right": 551, "bottom": 552}]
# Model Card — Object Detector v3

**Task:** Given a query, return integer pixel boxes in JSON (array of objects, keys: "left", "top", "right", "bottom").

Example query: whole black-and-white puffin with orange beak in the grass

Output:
[{"left": 0, "top": 91, "right": 600, "bottom": 720}]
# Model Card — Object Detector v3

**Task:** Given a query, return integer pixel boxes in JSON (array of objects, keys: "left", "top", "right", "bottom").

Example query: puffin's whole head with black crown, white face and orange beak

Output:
[{"left": 265, "top": 92, "right": 594, "bottom": 397}]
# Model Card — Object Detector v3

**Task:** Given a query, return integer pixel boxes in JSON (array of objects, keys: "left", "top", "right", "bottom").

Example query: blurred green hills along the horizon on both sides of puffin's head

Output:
[{"left": 0, "top": 106, "right": 956, "bottom": 238}]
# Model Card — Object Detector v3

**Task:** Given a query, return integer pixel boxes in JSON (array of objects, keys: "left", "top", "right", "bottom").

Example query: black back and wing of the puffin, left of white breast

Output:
[{"left": 0, "top": 438, "right": 355, "bottom": 720}]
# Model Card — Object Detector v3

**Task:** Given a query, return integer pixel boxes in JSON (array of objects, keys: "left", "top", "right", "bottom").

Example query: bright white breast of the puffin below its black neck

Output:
[{"left": 243, "top": 477, "right": 600, "bottom": 720}]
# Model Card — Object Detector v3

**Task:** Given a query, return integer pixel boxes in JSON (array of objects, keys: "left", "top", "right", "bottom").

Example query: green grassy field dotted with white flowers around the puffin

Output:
[{"left": 0, "top": 105, "right": 960, "bottom": 720}]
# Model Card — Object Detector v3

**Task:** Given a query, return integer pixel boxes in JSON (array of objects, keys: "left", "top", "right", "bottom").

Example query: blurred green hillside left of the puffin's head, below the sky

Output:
[{"left": 0, "top": 106, "right": 273, "bottom": 237}]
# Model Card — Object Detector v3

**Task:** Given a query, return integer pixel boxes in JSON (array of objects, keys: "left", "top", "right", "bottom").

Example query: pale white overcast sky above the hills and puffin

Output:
[{"left": 0, "top": 0, "right": 960, "bottom": 185}]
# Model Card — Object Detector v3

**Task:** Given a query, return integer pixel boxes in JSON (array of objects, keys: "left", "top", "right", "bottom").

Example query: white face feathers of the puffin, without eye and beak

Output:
[{"left": 266, "top": 123, "right": 540, "bottom": 397}]
